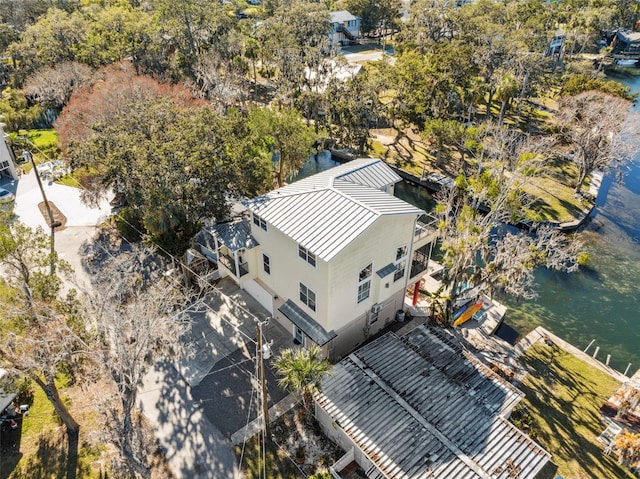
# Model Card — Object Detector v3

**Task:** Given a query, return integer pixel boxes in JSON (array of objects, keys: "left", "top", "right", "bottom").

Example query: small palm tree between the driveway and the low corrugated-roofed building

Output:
[{"left": 274, "top": 344, "right": 331, "bottom": 411}]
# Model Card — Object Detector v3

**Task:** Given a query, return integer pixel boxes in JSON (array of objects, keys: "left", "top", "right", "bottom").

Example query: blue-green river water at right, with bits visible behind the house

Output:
[{"left": 291, "top": 87, "right": 640, "bottom": 375}]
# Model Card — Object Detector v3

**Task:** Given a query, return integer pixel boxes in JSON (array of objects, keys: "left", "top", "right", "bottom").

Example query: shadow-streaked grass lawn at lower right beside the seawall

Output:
[{"left": 520, "top": 343, "right": 634, "bottom": 479}]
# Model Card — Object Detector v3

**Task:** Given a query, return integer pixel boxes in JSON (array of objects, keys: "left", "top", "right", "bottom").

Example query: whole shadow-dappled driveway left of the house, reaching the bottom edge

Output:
[{"left": 139, "top": 280, "right": 292, "bottom": 479}]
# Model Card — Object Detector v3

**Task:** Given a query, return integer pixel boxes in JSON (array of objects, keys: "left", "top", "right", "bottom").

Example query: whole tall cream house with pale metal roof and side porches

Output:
[{"left": 197, "top": 158, "right": 436, "bottom": 359}]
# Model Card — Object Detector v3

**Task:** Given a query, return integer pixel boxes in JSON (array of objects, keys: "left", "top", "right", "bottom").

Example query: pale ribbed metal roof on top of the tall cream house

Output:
[{"left": 248, "top": 158, "right": 424, "bottom": 261}]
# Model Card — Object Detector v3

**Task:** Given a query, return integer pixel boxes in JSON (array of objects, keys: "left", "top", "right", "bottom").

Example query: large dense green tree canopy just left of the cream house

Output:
[{"left": 69, "top": 98, "right": 266, "bottom": 251}]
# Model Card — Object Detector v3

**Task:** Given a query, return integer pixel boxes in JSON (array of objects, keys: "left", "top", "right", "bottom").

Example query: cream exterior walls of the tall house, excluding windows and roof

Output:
[{"left": 251, "top": 215, "right": 416, "bottom": 356}]
